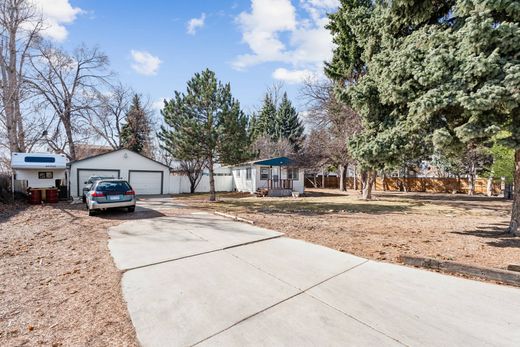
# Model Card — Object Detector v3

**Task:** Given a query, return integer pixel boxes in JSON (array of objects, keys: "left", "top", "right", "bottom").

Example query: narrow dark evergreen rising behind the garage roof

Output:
[{"left": 120, "top": 94, "right": 152, "bottom": 156}]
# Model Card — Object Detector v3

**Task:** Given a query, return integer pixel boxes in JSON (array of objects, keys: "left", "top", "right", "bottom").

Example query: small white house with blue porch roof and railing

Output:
[{"left": 231, "top": 157, "right": 305, "bottom": 196}]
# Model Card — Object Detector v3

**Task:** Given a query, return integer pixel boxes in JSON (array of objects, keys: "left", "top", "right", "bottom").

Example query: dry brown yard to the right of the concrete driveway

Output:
[{"left": 177, "top": 190, "right": 520, "bottom": 269}]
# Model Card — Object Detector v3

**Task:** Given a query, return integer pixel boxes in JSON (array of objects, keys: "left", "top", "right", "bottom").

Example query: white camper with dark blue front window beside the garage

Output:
[{"left": 11, "top": 153, "right": 68, "bottom": 192}]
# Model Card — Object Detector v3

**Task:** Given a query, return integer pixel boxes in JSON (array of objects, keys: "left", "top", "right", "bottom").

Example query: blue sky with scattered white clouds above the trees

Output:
[{"left": 40, "top": 0, "right": 337, "bottom": 117}]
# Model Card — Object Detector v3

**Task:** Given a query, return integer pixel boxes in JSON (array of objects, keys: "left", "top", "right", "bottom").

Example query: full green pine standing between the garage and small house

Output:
[{"left": 160, "top": 69, "right": 247, "bottom": 201}]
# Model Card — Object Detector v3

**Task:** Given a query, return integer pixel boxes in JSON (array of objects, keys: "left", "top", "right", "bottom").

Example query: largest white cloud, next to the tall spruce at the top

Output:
[{"left": 232, "top": 0, "right": 339, "bottom": 83}]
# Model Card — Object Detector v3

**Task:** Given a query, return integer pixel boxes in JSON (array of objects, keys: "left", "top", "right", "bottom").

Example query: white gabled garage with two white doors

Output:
[{"left": 69, "top": 149, "right": 170, "bottom": 197}]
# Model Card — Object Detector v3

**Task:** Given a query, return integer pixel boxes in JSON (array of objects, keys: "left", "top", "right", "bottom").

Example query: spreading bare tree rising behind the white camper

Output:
[{"left": 30, "top": 44, "right": 111, "bottom": 160}]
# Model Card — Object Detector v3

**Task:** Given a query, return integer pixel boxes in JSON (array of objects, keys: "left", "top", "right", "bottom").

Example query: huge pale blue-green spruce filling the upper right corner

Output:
[{"left": 330, "top": 0, "right": 520, "bottom": 234}]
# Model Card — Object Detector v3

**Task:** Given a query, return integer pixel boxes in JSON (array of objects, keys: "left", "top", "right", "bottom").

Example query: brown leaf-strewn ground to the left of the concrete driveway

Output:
[{"left": 0, "top": 203, "right": 189, "bottom": 346}]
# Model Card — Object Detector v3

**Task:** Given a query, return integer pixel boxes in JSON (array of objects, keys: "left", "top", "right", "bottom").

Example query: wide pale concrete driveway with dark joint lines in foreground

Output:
[{"left": 109, "top": 208, "right": 520, "bottom": 346}]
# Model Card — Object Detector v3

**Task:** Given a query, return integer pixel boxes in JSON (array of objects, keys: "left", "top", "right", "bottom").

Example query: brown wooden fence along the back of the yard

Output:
[{"left": 305, "top": 175, "right": 501, "bottom": 195}]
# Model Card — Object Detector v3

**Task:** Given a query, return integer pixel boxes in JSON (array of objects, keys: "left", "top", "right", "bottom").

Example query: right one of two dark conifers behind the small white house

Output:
[{"left": 274, "top": 93, "right": 304, "bottom": 153}]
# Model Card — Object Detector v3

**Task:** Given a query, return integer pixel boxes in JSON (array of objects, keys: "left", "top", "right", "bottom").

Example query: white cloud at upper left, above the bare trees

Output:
[{"left": 32, "top": 0, "right": 83, "bottom": 42}]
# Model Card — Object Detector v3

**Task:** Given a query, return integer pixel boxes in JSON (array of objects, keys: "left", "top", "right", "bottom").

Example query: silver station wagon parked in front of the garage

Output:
[{"left": 85, "top": 179, "right": 136, "bottom": 216}]
